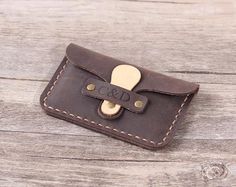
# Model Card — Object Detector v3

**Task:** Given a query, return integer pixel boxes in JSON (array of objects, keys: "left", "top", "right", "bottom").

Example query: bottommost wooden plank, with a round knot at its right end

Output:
[{"left": 0, "top": 156, "right": 236, "bottom": 187}]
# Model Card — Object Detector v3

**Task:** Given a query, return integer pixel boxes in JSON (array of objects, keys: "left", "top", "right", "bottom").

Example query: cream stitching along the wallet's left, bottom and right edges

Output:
[{"left": 43, "top": 60, "right": 189, "bottom": 145}]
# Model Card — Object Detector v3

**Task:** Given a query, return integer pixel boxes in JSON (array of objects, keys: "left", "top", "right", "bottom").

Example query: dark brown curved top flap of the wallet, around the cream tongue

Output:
[{"left": 66, "top": 44, "right": 199, "bottom": 96}]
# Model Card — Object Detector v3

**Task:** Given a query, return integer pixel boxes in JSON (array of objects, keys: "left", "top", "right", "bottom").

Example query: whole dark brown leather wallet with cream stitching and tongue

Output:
[{"left": 40, "top": 44, "right": 199, "bottom": 150}]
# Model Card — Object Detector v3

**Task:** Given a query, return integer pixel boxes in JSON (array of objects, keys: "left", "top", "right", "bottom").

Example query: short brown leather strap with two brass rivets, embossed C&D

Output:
[{"left": 82, "top": 78, "right": 148, "bottom": 113}]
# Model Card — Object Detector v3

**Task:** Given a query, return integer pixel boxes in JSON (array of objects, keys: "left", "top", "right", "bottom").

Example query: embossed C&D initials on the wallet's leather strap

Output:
[{"left": 97, "top": 86, "right": 130, "bottom": 102}]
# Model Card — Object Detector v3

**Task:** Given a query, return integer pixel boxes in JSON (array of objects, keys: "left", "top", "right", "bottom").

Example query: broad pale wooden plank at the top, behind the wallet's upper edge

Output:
[{"left": 0, "top": 0, "right": 236, "bottom": 80}]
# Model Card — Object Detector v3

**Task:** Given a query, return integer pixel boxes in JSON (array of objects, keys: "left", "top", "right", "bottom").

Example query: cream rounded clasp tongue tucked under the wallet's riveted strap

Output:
[{"left": 101, "top": 65, "right": 141, "bottom": 116}]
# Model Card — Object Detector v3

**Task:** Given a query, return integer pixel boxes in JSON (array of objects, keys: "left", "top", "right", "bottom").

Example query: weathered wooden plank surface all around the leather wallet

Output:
[{"left": 0, "top": 0, "right": 236, "bottom": 187}]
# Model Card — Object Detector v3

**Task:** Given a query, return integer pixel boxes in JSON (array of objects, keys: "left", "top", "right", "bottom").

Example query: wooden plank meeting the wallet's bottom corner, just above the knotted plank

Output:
[{"left": 0, "top": 131, "right": 236, "bottom": 162}]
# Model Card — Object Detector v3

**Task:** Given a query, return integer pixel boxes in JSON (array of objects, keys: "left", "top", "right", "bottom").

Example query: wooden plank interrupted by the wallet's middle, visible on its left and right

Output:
[{"left": 0, "top": 79, "right": 236, "bottom": 139}]
